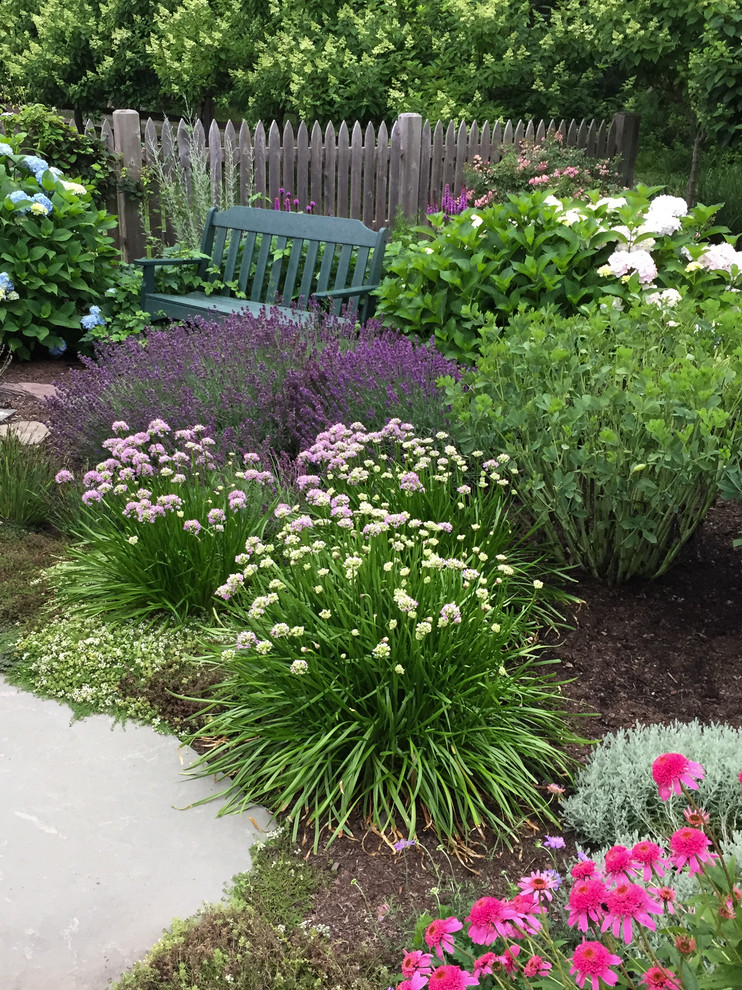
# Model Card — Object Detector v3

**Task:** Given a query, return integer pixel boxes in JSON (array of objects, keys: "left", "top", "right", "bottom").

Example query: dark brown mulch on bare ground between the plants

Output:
[{"left": 4, "top": 361, "right": 742, "bottom": 976}]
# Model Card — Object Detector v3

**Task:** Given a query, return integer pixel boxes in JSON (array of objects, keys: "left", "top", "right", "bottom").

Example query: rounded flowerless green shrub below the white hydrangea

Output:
[{"left": 449, "top": 297, "right": 742, "bottom": 584}]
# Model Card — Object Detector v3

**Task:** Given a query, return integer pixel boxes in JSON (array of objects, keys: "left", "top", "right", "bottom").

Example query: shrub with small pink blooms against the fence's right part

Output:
[{"left": 464, "top": 131, "right": 620, "bottom": 207}]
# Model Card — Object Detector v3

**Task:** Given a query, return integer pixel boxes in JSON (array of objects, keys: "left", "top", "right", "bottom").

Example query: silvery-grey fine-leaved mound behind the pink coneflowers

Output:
[{"left": 561, "top": 720, "right": 742, "bottom": 849}]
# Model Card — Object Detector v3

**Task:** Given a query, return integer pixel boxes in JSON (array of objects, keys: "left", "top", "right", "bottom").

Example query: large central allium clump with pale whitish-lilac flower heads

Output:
[{"left": 187, "top": 420, "right": 573, "bottom": 847}]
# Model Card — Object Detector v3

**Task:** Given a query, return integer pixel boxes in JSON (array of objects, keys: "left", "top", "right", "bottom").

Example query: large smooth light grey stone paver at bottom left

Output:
[{"left": 0, "top": 678, "right": 269, "bottom": 990}]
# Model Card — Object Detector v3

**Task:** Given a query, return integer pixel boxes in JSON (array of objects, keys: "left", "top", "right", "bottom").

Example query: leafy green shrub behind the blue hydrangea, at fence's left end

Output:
[{"left": 2, "top": 103, "right": 118, "bottom": 205}]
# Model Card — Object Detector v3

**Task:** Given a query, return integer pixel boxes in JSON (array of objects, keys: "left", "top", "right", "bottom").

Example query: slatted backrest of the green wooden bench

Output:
[{"left": 199, "top": 206, "right": 387, "bottom": 312}]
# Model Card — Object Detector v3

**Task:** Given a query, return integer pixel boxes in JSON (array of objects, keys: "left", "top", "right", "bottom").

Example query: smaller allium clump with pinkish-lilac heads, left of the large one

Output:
[{"left": 53, "top": 419, "right": 275, "bottom": 622}]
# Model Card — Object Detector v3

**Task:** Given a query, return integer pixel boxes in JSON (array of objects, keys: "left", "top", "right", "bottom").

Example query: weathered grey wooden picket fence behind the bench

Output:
[{"left": 85, "top": 110, "right": 639, "bottom": 258}]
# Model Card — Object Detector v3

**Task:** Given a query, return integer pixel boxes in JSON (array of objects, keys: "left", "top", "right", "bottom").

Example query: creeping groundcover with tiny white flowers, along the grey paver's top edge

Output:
[{"left": 8, "top": 612, "right": 203, "bottom": 729}]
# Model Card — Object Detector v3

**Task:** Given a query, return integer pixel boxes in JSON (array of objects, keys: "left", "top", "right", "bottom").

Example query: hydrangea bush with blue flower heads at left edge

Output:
[{"left": 0, "top": 136, "right": 117, "bottom": 358}]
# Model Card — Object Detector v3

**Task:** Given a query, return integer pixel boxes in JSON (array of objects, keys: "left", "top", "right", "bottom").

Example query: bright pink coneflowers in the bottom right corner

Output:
[{"left": 397, "top": 753, "right": 742, "bottom": 990}]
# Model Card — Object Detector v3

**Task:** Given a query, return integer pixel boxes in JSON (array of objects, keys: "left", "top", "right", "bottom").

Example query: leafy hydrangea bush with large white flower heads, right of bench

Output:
[{"left": 378, "top": 187, "right": 736, "bottom": 360}]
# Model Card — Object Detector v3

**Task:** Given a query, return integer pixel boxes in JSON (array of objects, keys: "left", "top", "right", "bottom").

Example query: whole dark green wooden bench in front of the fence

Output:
[{"left": 135, "top": 206, "right": 387, "bottom": 322}]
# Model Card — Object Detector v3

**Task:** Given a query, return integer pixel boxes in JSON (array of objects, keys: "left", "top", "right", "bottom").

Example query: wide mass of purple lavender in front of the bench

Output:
[{"left": 48, "top": 309, "right": 457, "bottom": 464}]
